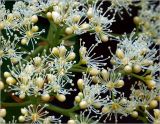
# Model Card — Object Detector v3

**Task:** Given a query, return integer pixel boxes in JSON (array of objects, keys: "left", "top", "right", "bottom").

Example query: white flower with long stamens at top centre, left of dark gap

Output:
[{"left": 87, "top": 0, "right": 115, "bottom": 42}]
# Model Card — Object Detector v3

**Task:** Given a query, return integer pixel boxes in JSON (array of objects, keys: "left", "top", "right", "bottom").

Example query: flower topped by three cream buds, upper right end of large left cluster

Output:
[{"left": 48, "top": 44, "right": 76, "bottom": 82}]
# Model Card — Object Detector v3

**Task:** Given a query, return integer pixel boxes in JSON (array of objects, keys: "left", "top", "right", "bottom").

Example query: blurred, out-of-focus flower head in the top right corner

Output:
[{"left": 135, "top": 3, "right": 160, "bottom": 44}]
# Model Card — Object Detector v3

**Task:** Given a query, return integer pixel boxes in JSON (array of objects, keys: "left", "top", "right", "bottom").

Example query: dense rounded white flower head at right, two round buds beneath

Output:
[{"left": 111, "top": 32, "right": 159, "bottom": 73}]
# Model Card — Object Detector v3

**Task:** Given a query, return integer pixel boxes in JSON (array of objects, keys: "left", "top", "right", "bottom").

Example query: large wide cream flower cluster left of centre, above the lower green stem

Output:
[{"left": 4, "top": 45, "right": 75, "bottom": 101}]
